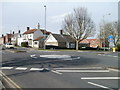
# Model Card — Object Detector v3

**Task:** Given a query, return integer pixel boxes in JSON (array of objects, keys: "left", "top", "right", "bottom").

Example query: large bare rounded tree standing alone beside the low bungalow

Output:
[{"left": 63, "top": 8, "right": 95, "bottom": 50}]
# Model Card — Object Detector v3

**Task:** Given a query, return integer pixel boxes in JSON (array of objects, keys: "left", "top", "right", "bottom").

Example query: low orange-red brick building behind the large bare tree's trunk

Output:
[{"left": 79, "top": 39, "right": 102, "bottom": 48}]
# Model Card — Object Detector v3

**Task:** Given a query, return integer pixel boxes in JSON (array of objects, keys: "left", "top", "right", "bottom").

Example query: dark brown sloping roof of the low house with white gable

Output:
[{"left": 52, "top": 34, "right": 75, "bottom": 42}]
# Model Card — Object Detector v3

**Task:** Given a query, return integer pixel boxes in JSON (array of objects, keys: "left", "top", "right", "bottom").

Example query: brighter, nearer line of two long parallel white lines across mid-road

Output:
[{"left": 56, "top": 70, "right": 109, "bottom": 72}]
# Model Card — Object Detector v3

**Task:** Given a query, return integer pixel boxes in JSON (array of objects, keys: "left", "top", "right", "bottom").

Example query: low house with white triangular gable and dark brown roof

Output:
[{"left": 45, "top": 30, "right": 75, "bottom": 48}]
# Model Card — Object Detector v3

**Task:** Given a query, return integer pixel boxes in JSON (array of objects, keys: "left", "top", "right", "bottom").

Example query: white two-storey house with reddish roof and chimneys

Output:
[{"left": 23, "top": 24, "right": 51, "bottom": 47}]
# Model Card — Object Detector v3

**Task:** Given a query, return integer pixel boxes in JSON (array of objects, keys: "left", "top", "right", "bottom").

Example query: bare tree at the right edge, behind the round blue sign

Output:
[{"left": 99, "top": 22, "right": 119, "bottom": 46}]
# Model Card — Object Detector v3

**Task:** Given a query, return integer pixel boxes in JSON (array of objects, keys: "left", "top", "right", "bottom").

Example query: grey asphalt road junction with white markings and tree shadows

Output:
[{"left": 1, "top": 50, "right": 119, "bottom": 90}]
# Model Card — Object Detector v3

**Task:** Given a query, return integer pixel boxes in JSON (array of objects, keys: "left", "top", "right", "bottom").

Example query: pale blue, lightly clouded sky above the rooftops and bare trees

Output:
[{"left": 0, "top": 0, "right": 118, "bottom": 38}]
